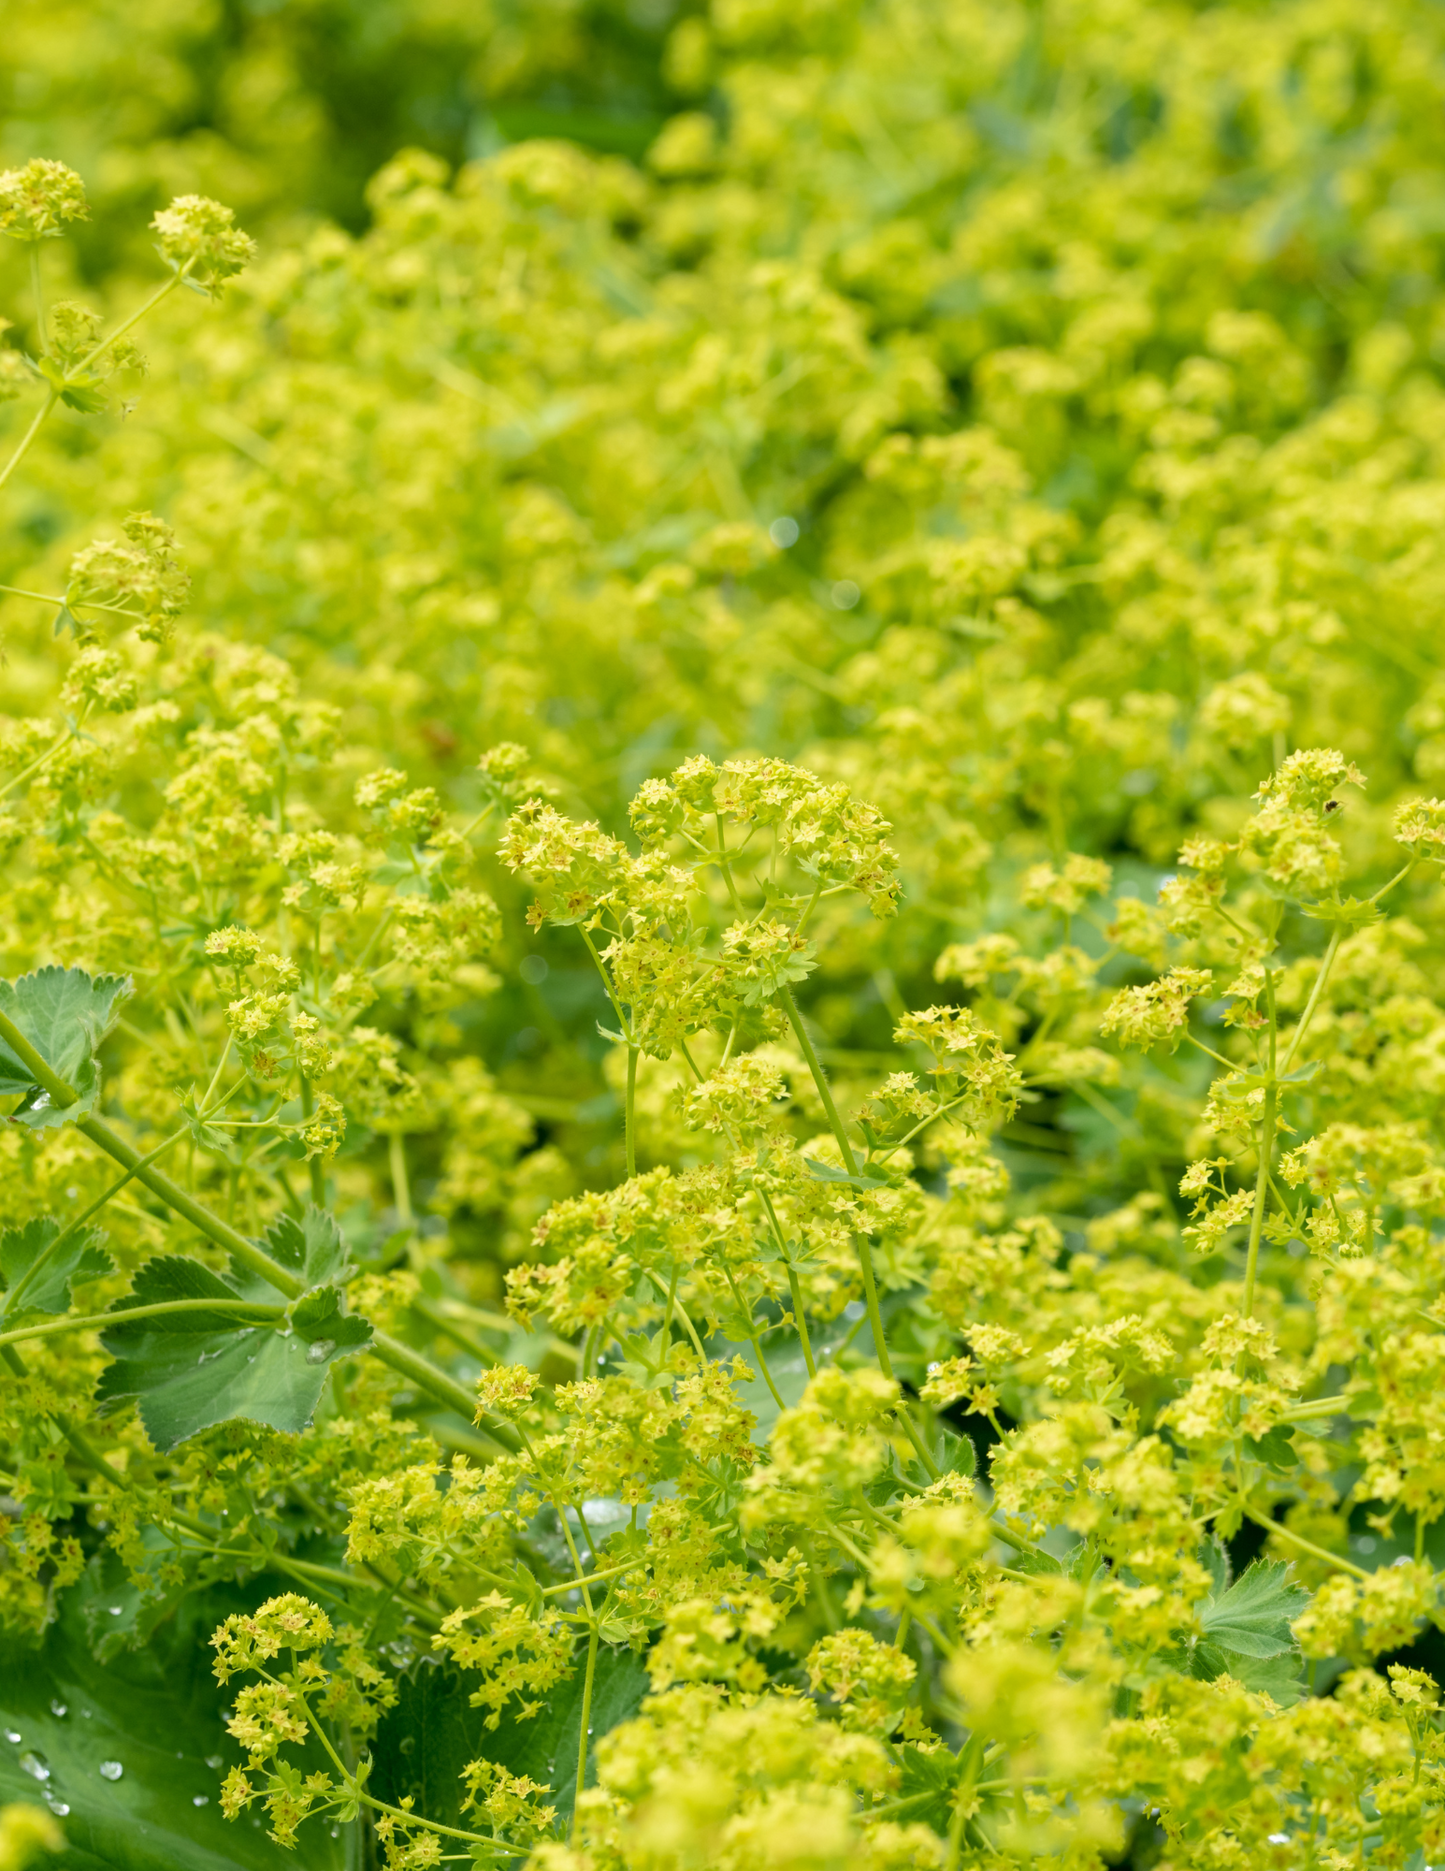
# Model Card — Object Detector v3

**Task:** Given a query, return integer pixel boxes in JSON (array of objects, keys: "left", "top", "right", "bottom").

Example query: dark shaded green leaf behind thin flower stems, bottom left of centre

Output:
[{"left": 371, "top": 1648, "right": 648, "bottom": 1830}]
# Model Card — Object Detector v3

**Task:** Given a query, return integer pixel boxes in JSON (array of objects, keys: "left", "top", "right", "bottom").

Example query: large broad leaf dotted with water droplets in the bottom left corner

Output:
[{"left": 0, "top": 1585, "right": 346, "bottom": 1871}]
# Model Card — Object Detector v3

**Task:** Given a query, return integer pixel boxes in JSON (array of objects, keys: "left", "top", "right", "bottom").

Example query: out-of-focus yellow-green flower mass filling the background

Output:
[{"left": 0, "top": 0, "right": 1445, "bottom": 1227}]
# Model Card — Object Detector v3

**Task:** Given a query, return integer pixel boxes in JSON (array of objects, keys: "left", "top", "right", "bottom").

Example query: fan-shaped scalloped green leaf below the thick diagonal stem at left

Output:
[{"left": 95, "top": 1255, "right": 371, "bottom": 1452}]
